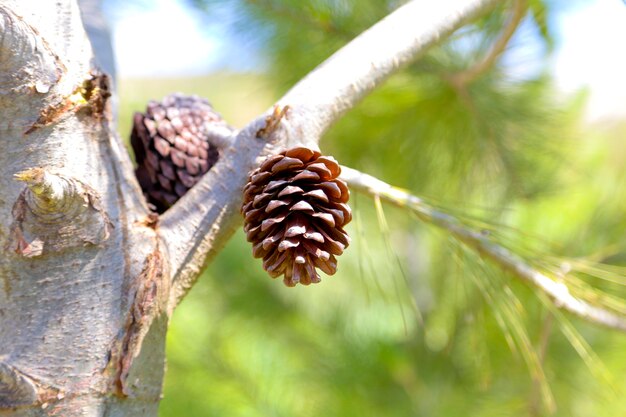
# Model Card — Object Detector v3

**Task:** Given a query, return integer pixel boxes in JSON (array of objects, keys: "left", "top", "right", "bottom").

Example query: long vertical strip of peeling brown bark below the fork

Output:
[{"left": 111, "top": 246, "right": 167, "bottom": 396}]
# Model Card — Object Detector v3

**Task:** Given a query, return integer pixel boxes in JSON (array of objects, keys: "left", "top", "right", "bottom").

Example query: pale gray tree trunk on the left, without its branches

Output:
[{"left": 0, "top": 0, "right": 168, "bottom": 416}]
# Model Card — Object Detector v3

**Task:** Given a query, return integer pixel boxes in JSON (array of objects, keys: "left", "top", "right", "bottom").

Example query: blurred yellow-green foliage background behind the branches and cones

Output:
[{"left": 113, "top": 0, "right": 626, "bottom": 417}]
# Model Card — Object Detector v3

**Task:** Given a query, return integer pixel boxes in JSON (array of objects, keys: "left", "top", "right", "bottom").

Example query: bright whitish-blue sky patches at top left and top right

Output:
[{"left": 108, "top": 0, "right": 626, "bottom": 120}]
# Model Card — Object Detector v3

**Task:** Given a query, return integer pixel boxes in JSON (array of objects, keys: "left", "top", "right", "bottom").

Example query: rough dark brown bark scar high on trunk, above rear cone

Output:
[{"left": 24, "top": 70, "right": 111, "bottom": 135}]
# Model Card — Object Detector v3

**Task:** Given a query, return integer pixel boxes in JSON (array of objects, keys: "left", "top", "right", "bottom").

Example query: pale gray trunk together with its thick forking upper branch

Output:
[{"left": 0, "top": 0, "right": 497, "bottom": 417}]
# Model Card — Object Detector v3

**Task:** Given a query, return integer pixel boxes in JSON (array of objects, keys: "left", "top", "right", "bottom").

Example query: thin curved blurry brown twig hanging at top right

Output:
[{"left": 447, "top": 0, "right": 527, "bottom": 86}]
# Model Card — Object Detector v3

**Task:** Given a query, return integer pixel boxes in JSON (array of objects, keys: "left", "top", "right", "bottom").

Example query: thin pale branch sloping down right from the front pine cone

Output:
[{"left": 341, "top": 167, "right": 626, "bottom": 332}]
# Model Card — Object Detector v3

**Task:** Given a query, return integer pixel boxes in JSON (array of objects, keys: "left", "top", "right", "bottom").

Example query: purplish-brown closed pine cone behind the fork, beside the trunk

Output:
[{"left": 130, "top": 94, "right": 228, "bottom": 213}]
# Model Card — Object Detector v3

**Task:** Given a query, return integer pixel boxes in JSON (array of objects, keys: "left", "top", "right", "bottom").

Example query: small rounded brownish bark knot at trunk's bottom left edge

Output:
[{"left": 0, "top": 362, "right": 37, "bottom": 410}]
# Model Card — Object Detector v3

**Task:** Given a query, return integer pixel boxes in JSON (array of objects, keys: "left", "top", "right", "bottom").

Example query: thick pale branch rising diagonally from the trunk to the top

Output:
[{"left": 160, "top": 0, "right": 503, "bottom": 308}]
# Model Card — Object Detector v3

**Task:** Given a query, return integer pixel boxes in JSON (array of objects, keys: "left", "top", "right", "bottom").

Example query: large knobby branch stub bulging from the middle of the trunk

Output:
[{"left": 6, "top": 168, "right": 113, "bottom": 258}]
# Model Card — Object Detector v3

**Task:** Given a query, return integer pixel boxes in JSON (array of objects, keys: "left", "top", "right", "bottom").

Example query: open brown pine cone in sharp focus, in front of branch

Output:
[{"left": 241, "top": 148, "right": 352, "bottom": 287}]
